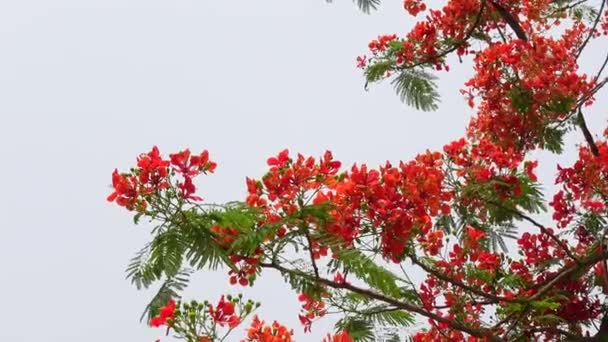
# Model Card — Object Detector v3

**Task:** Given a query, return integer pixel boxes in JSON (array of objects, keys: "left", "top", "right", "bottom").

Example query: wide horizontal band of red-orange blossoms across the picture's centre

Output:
[{"left": 247, "top": 151, "right": 452, "bottom": 261}]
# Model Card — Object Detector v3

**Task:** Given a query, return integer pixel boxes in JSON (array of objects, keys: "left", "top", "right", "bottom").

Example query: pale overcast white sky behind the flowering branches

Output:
[{"left": 0, "top": 0, "right": 605, "bottom": 342}]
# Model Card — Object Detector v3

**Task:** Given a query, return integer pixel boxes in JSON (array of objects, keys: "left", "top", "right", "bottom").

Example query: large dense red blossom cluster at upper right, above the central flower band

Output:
[{"left": 465, "top": 28, "right": 594, "bottom": 151}]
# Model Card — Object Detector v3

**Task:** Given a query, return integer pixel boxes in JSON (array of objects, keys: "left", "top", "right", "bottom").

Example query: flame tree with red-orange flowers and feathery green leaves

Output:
[{"left": 108, "top": 0, "right": 608, "bottom": 342}]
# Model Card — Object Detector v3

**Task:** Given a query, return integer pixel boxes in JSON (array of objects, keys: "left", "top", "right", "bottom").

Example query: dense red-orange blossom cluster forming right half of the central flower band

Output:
[{"left": 334, "top": 152, "right": 452, "bottom": 262}]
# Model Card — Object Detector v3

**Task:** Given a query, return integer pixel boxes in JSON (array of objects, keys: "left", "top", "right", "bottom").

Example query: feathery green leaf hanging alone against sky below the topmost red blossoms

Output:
[{"left": 391, "top": 69, "right": 439, "bottom": 112}]
